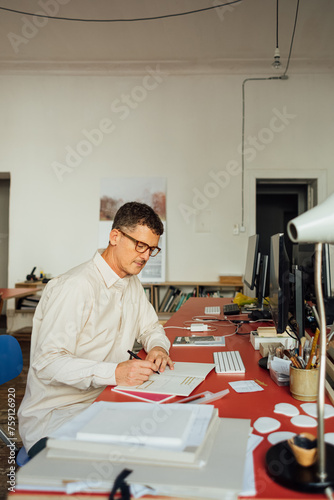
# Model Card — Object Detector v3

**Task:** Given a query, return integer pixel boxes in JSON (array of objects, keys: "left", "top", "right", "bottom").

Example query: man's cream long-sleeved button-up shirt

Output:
[{"left": 18, "top": 253, "right": 170, "bottom": 451}]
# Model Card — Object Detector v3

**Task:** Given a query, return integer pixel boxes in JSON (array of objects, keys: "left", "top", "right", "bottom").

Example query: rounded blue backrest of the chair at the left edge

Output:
[{"left": 0, "top": 335, "right": 23, "bottom": 385}]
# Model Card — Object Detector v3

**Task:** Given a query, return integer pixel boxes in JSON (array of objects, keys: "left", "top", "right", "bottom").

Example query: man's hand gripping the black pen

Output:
[{"left": 115, "top": 359, "right": 157, "bottom": 386}]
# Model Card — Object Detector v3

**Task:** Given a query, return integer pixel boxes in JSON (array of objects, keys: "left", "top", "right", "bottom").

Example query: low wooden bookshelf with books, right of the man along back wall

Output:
[{"left": 143, "top": 276, "right": 243, "bottom": 319}]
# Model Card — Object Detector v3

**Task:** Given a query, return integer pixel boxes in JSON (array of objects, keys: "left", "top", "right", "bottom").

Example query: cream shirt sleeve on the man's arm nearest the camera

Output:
[{"left": 31, "top": 283, "right": 117, "bottom": 390}]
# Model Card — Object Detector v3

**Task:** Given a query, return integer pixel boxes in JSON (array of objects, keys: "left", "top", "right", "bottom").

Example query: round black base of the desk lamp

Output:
[{"left": 266, "top": 441, "right": 334, "bottom": 493}]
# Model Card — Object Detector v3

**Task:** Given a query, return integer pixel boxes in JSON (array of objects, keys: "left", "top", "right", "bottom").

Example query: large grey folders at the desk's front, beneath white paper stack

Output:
[{"left": 16, "top": 410, "right": 250, "bottom": 500}]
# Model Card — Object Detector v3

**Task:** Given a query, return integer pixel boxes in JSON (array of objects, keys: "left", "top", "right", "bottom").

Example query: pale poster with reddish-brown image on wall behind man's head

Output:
[{"left": 99, "top": 177, "right": 166, "bottom": 283}]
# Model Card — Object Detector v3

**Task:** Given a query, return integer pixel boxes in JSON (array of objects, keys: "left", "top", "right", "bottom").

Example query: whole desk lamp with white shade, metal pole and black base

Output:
[{"left": 266, "top": 194, "right": 334, "bottom": 493}]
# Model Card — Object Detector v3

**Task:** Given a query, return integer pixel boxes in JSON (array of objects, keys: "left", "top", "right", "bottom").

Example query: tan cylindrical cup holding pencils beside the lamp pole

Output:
[{"left": 290, "top": 366, "right": 319, "bottom": 401}]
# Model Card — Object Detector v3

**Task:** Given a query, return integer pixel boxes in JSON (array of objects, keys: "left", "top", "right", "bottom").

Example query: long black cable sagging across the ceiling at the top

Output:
[{"left": 0, "top": 0, "right": 243, "bottom": 23}]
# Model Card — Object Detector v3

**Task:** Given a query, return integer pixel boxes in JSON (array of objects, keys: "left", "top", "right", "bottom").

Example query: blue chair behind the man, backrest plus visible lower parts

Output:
[{"left": 0, "top": 335, "right": 30, "bottom": 467}]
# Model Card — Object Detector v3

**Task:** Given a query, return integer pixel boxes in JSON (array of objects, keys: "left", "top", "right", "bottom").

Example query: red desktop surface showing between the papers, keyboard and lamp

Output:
[{"left": 98, "top": 298, "right": 334, "bottom": 499}]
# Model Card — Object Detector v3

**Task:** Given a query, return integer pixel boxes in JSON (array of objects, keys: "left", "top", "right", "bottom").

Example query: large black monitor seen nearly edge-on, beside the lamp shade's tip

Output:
[{"left": 269, "top": 233, "right": 290, "bottom": 333}]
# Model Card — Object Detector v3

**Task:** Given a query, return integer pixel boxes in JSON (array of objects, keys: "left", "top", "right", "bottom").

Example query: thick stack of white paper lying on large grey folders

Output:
[{"left": 47, "top": 401, "right": 218, "bottom": 467}]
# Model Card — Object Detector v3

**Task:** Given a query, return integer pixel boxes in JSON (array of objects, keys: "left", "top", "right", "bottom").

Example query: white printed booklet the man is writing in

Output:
[{"left": 116, "top": 361, "right": 215, "bottom": 396}]
